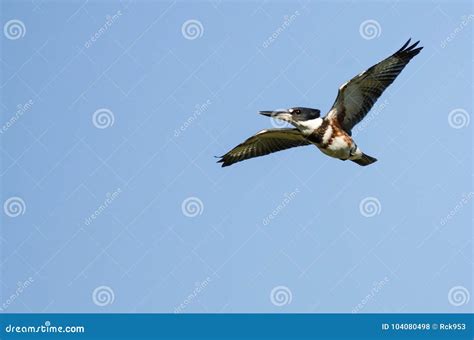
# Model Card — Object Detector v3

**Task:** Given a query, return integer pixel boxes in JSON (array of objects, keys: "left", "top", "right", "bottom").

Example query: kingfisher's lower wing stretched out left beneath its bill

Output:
[{"left": 217, "top": 128, "right": 311, "bottom": 167}]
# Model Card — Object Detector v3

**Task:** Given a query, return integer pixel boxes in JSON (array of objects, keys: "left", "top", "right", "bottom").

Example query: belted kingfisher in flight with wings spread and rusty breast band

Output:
[{"left": 218, "top": 39, "right": 423, "bottom": 167}]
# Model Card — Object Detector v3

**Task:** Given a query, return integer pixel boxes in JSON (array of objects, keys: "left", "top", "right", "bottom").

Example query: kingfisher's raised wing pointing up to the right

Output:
[{"left": 328, "top": 39, "right": 423, "bottom": 134}]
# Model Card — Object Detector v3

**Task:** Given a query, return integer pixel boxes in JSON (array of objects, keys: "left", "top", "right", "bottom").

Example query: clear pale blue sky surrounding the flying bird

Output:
[{"left": 0, "top": 0, "right": 474, "bottom": 313}]
